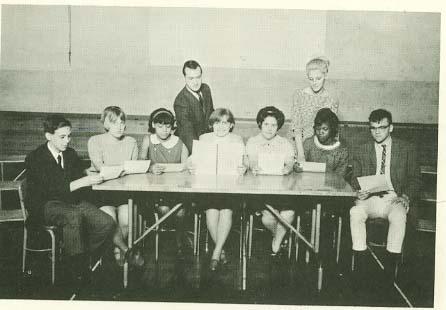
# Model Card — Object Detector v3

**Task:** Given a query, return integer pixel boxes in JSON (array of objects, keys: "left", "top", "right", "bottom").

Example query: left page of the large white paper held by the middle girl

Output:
[{"left": 192, "top": 140, "right": 217, "bottom": 175}]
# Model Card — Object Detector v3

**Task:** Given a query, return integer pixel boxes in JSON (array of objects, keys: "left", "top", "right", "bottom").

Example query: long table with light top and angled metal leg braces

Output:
[{"left": 93, "top": 171, "right": 356, "bottom": 290}]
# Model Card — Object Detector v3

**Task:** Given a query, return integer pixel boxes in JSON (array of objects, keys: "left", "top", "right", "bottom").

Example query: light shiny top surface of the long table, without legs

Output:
[{"left": 93, "top": 171, "right": 356, "bottom": 197}]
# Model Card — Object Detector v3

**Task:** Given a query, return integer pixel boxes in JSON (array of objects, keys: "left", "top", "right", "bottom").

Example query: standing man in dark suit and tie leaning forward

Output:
[{"left": 173, "top": 60, "right": 214, "bottom": 154}]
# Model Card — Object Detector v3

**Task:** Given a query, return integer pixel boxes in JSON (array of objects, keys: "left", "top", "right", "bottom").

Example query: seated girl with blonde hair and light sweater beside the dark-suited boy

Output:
[{"left": 88, "top": 106, "right": 138, "bottom": 262}]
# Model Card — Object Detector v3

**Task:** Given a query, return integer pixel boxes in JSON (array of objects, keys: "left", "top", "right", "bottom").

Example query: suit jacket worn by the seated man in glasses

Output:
[{"left": 352, "top": 137, "right": 421, "bottom": 201}]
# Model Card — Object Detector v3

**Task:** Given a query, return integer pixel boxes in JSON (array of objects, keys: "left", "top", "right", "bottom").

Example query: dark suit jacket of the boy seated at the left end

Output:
[{"left": 25, "top": 143, "right": 83, "bottom": 223}]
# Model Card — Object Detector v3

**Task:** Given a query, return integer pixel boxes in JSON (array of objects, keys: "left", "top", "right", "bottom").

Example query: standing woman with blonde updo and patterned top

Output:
[{"left": 291, "top": 57, "right": 339, "bottom": 162}]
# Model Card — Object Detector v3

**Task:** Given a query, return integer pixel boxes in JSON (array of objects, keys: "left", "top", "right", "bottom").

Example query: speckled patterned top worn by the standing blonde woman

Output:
[{"left": 291, "top": 89, "right": 339, "bottom": 140}]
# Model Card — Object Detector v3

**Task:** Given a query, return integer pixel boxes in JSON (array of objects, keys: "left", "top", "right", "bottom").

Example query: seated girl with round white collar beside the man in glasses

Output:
[{"left": 297, "top": 108, "right": 348, "bottom": 177}]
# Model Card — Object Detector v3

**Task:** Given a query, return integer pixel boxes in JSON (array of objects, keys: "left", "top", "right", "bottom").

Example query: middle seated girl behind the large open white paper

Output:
[{"left": 192, "top": 108, "right": 246, "bottom": 271}]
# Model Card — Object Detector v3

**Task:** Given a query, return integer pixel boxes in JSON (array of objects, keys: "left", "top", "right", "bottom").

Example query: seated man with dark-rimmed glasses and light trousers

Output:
[{"left": 350, "top": 109, "right": 421, "bottom": 285}]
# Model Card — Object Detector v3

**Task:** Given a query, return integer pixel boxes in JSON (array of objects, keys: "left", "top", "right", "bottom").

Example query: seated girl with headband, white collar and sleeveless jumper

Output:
[{"left": 139, "top": 108, "right": 189, "bottom": 256}]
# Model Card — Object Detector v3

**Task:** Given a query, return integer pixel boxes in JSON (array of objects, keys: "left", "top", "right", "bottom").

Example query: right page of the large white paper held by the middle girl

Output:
[{"left": 217, "top": 143, "right": 245, "bottom": 175}]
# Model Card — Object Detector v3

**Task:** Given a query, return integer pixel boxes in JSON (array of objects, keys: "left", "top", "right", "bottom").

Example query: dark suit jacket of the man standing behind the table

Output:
[{"left": 173, "top": 83, "right": 214, "bottom": 154}]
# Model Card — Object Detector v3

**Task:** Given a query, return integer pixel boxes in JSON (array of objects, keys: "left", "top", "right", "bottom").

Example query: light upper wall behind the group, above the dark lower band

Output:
[{"left": 0, "top": 5, "right": 440, "bottom": 123}]
